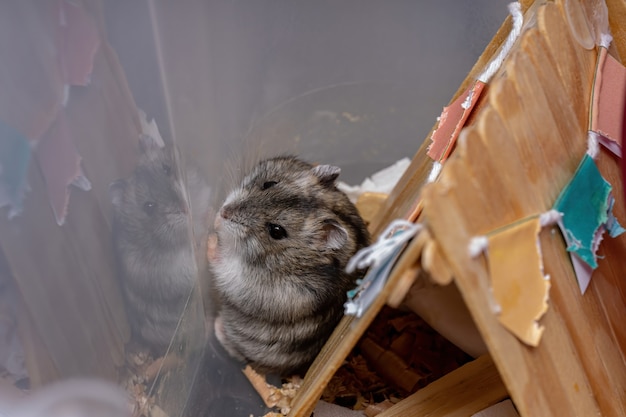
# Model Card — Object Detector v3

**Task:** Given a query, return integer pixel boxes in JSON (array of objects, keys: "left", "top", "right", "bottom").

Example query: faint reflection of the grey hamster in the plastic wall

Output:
[{"left": 110, "top": 135, "right": 208, "bottom": 354}]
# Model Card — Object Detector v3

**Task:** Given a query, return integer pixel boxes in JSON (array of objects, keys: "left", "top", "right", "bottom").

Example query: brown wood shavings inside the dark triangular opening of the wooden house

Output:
[{"left": 322, "top": 307, "right": 472, "bottom": 416}]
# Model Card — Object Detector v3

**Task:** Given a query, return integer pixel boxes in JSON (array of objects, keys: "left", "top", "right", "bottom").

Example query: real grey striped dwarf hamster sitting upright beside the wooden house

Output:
[{"left": 211, "top": 156, "right": 369, "bottom": 375}]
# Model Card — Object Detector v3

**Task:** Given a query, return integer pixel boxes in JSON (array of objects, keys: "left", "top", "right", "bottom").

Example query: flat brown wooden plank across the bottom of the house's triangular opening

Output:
[{"left": 378, "top": 355, "right": 507, "bottom": 417}]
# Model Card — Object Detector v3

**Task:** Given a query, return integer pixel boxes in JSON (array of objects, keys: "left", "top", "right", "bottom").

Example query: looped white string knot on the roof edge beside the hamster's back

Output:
[{"left": 346, "top": 220, "right": 423, "bottom": 274}]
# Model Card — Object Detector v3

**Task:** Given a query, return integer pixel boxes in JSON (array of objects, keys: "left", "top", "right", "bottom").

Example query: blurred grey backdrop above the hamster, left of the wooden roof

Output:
[{"left": 106, "top": 0, "right": 507, "bottom": 189}]
